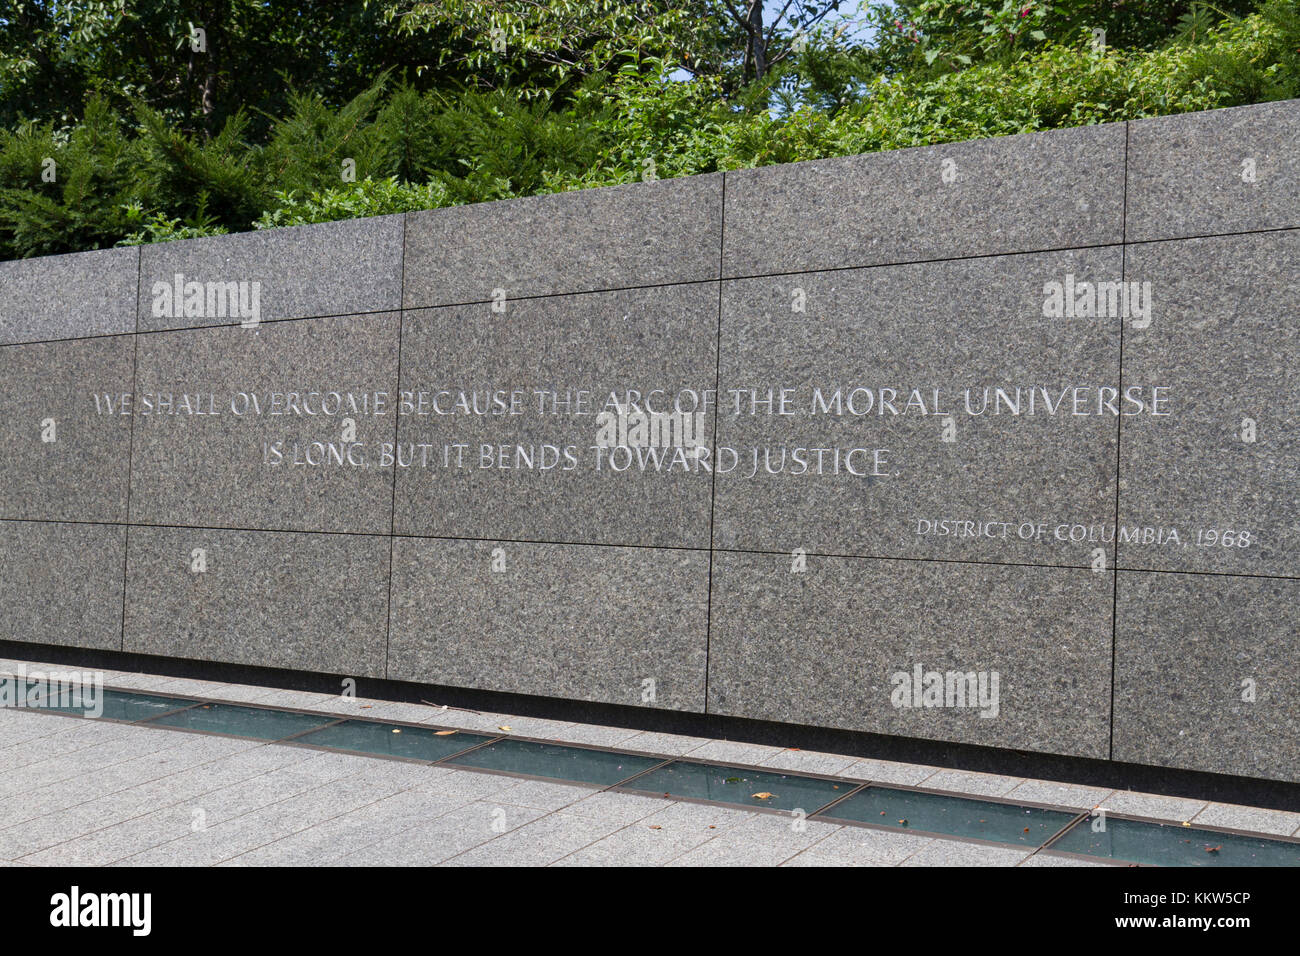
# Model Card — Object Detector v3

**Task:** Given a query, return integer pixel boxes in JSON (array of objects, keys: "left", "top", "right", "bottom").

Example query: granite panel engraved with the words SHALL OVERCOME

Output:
[{"left": 131, "top": 315, "right": 398, "bottom": 535}]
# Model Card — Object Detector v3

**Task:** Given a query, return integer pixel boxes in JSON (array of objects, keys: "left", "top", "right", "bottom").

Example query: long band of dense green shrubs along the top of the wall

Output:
[{"left": 0, "top": 0, "right": 1300, "bottom": 259}]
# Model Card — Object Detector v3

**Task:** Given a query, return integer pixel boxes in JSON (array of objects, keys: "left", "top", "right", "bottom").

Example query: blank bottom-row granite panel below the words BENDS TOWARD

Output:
[{"left": 389, "top": 537, "right": 709, "bottom": 711}]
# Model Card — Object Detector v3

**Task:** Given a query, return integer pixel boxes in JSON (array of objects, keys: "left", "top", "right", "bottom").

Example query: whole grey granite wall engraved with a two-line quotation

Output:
[{"left": 0, "top": 101, "right": 1300, "bottom": 780}]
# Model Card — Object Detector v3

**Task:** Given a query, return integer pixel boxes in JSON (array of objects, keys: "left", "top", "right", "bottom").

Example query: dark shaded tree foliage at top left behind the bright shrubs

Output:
[{"left": 0, "top": 0, "right": 471, "bottom": 140}]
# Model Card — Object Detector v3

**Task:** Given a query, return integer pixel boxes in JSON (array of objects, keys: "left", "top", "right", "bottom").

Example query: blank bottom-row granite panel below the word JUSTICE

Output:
[{"left": 709, "top": 553, "right": 1114, "bottom": 758}]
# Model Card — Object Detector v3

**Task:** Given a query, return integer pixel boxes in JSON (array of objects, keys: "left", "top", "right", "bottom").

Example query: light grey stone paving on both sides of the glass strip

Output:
[{"left": 0, "top": 659, "right": 1300, "bottom": 866}]
